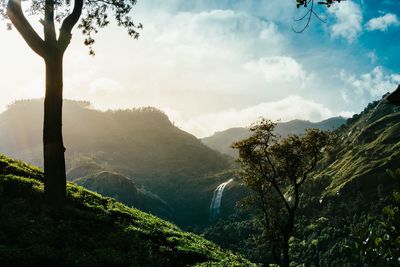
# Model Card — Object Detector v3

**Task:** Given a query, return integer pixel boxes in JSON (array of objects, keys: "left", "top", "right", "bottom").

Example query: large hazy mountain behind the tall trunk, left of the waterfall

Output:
[{"left": 0, "top": 100, "right": 230, "bottom": 229}]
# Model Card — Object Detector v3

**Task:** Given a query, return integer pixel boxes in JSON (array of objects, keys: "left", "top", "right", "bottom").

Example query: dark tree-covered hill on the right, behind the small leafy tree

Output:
[{"left": 205, "top": 98, "right": 400, "bottom": 266}]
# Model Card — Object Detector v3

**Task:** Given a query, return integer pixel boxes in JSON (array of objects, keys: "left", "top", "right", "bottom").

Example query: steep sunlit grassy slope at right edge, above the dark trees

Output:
[{"left": 315, "top": 99, "right": 400, "bottom": 197}]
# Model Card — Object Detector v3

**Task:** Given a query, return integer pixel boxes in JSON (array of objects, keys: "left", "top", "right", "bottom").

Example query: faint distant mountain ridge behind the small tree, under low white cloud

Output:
[{"left": 201, "top": 117, "right": 346, "bottom": 157}]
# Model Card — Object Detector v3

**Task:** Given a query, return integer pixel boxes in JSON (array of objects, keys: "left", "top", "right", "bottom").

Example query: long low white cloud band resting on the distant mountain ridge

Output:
[{"left": 166, "top": 95, "right": 346, "bottom": 137}]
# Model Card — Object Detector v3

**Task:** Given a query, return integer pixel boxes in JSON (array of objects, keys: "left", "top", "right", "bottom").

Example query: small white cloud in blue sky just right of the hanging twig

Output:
[{"left": 329, "top": 1, "right": 363, "bottom": 43}]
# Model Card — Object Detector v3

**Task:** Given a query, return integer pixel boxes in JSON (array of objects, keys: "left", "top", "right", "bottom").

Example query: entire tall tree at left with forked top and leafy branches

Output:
[{"left": 0, "top": 0, "right": 142, "bottom": 206}]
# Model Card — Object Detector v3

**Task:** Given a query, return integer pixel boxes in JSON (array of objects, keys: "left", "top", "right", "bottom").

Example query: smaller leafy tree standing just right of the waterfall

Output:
[{"left": 233, "top": 119, "right": 330, "bottom": 266}]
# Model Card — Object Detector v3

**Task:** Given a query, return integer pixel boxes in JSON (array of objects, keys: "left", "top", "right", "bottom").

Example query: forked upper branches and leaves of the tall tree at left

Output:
[{"left": 0, "top": 0, "right": 143, "bottom": 56}]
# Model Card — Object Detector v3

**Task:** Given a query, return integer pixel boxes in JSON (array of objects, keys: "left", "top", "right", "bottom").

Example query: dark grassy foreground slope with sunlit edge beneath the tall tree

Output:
[{"left": 0, "top": 155, "right": 253, "bottom": 266}]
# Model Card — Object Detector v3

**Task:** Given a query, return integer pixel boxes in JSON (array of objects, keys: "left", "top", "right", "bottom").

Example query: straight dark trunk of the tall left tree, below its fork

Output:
[{"left": 43, "top": 52, "right": 67, "bottom": 207}]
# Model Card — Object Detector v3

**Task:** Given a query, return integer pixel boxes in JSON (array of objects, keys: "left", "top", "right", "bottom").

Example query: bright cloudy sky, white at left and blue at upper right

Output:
[{"left": 0, "top": 0, "right": 400, "bottom": 138}]
